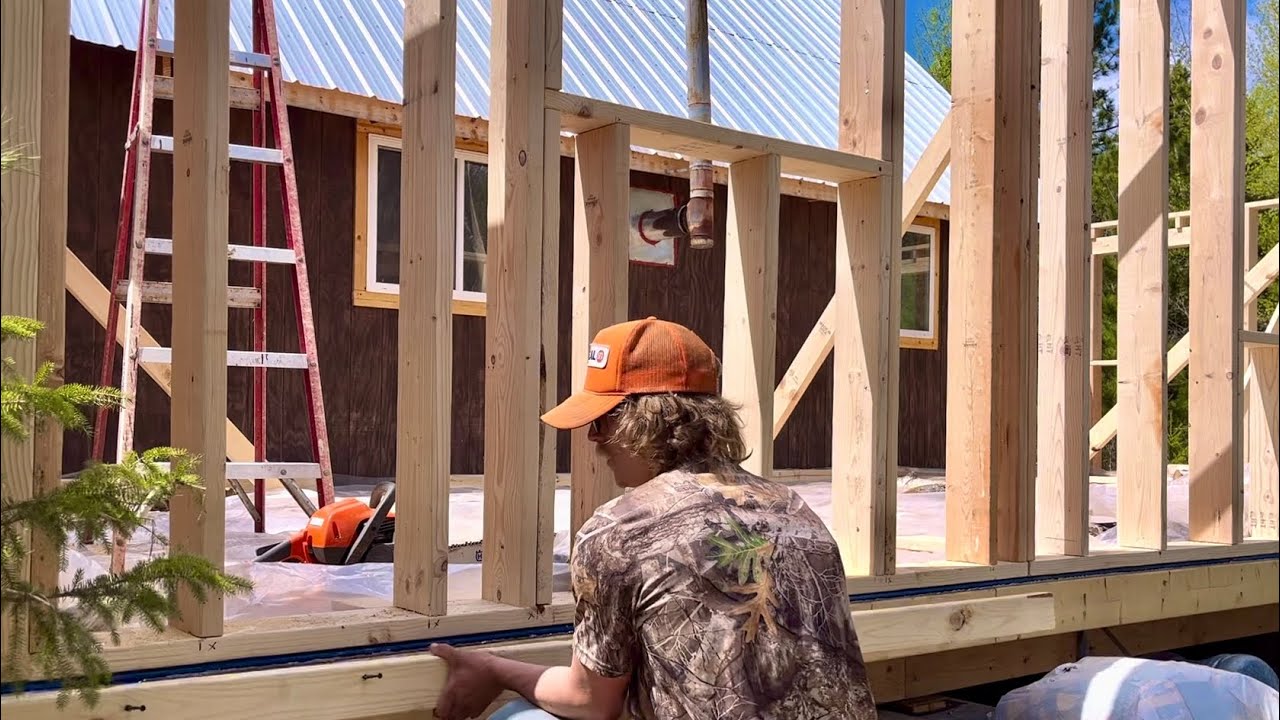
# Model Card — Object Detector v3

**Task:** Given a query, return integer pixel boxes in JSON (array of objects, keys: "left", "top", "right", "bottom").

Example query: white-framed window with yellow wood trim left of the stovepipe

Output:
[{"left": 357, "top": 132, "right": 489, "bottom": 305}]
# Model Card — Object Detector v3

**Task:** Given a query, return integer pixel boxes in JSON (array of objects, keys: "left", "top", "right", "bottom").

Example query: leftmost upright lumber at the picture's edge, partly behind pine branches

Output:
[{"left": 0, "top": 0, "right": 70, "bottom": 666}]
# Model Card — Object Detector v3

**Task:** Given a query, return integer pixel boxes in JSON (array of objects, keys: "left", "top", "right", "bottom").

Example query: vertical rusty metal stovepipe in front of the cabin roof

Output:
[{"left": 682, "top": 0, "right": 716, "bottom": 250}]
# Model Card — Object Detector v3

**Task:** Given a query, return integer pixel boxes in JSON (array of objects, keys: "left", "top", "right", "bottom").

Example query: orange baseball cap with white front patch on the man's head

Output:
[{"left": 543, "top": 316, "right": 719, "bottom": 430}]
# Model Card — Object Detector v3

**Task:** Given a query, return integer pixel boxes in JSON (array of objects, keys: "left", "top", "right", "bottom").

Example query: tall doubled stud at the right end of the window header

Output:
[{"left": 832, "top": 0, "right": 918, "bottom": 575}]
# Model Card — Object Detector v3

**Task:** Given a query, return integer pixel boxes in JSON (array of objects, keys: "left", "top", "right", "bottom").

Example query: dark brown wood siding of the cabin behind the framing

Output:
[{"left": 64, "top": 41, "right": 946, "bottom": 477}]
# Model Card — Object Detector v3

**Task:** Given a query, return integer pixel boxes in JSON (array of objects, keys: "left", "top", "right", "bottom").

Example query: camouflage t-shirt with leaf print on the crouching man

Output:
[{"left": 571, "top": 471, "right": 876, "bottom": 720}]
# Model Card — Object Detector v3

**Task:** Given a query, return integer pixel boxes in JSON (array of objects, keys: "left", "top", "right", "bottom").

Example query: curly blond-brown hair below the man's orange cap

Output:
[{"left": 608, "top": 392, "right": 750, "bottom": 474}]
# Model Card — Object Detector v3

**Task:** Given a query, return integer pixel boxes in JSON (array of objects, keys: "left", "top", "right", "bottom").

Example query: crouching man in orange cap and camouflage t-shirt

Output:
[{"left": 431, "top": 318, "right": 876, "bottom": 720}]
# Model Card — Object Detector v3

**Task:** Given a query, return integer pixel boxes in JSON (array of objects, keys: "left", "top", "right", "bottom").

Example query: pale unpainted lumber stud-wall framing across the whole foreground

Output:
[{"left": 4, "top": 0, "right": 1280, "bottom": 717}]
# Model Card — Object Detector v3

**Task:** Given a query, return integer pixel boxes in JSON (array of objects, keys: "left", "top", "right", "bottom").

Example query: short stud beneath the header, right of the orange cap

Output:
[{"left": 721, "top": 151, "right": 781, "bottom": 478}]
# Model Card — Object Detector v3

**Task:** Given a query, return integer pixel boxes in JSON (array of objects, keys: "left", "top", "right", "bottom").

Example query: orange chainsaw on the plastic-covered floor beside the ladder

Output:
[{"left": 255, "top": 482, "right": 396, "bottom": 565}]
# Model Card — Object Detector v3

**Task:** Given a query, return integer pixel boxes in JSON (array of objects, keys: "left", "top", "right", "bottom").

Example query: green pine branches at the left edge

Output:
[{"left": 0, "top": 316, "right": 252, "bottom": 706}]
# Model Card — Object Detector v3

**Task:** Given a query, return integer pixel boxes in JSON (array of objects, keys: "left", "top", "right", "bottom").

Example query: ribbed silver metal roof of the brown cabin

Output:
[{"left": 70, "top": 0, "right": 951, "bottom": 202}]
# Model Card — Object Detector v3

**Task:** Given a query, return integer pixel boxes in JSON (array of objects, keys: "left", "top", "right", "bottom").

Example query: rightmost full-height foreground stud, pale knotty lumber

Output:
[{"left": 1187, "top": 0, "right": 1247, "bottom": 543}]
